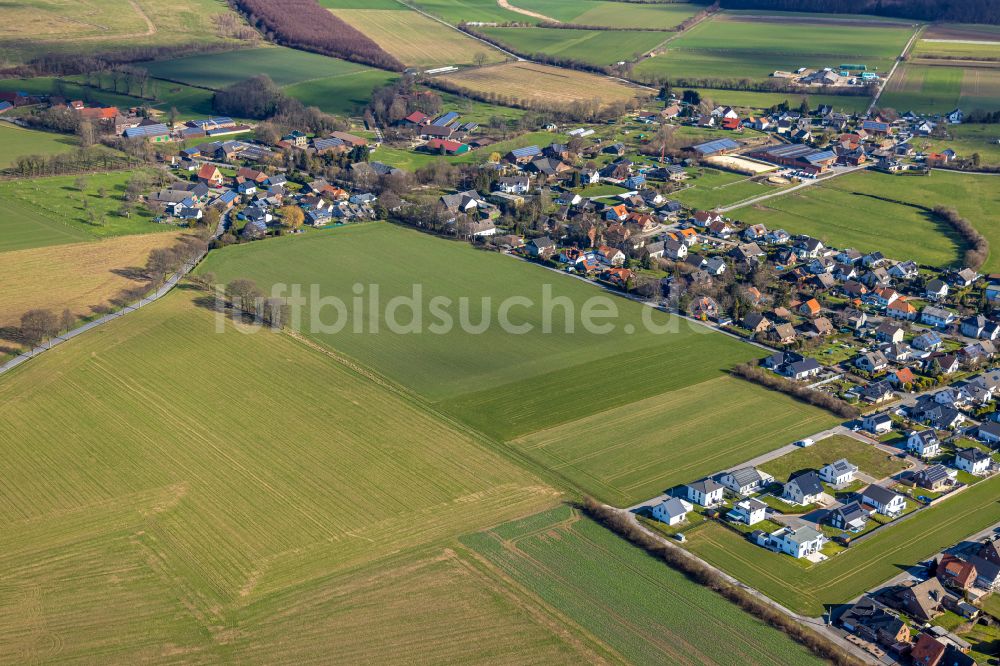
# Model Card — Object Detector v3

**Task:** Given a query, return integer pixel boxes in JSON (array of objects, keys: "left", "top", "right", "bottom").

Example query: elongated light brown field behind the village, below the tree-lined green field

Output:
[{"left": 438, "top": 62, "right": 649, "bottom": 105}]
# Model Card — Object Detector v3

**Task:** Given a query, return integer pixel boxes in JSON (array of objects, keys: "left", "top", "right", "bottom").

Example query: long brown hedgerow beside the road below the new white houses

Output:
[{"left": 578, "top": 497, "right": 864, "bottom": 666}]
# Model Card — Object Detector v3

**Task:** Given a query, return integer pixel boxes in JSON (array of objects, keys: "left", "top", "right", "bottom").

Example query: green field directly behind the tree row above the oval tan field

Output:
[{"left": 479, "top": 28, "right": 668, "bottom": 65}]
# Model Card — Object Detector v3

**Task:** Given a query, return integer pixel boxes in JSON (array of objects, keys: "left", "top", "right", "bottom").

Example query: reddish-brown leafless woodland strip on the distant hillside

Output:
[{"left": 231, "top": 0, "right": 405, "bottom": 72}]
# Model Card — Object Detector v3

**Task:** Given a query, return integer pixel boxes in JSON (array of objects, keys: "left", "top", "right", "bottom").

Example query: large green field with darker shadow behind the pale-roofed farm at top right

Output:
[{"left": 636, "top": 15, "right": 912, "bottom": 79}]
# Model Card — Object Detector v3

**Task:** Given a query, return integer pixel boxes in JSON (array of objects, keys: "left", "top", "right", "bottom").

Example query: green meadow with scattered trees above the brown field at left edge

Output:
[{"left": 0, "top": 171, "right": 176, "bottom": 251}]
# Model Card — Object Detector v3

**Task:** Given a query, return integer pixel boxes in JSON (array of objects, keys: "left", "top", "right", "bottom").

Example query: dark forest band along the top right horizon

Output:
[{"left": 722, "top": 0, "right": 1000, "bottom": 24}]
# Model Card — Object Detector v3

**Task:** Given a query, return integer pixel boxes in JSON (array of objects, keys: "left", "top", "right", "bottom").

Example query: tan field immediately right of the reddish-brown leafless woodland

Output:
[{"left": 330, "top": 9, "right": 505, "bottom": 67}]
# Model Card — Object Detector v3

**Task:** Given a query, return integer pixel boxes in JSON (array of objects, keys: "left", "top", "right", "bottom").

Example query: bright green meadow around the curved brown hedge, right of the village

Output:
[{"left": 732, "top": 170, "right": 1000, "bottom": 270}]
